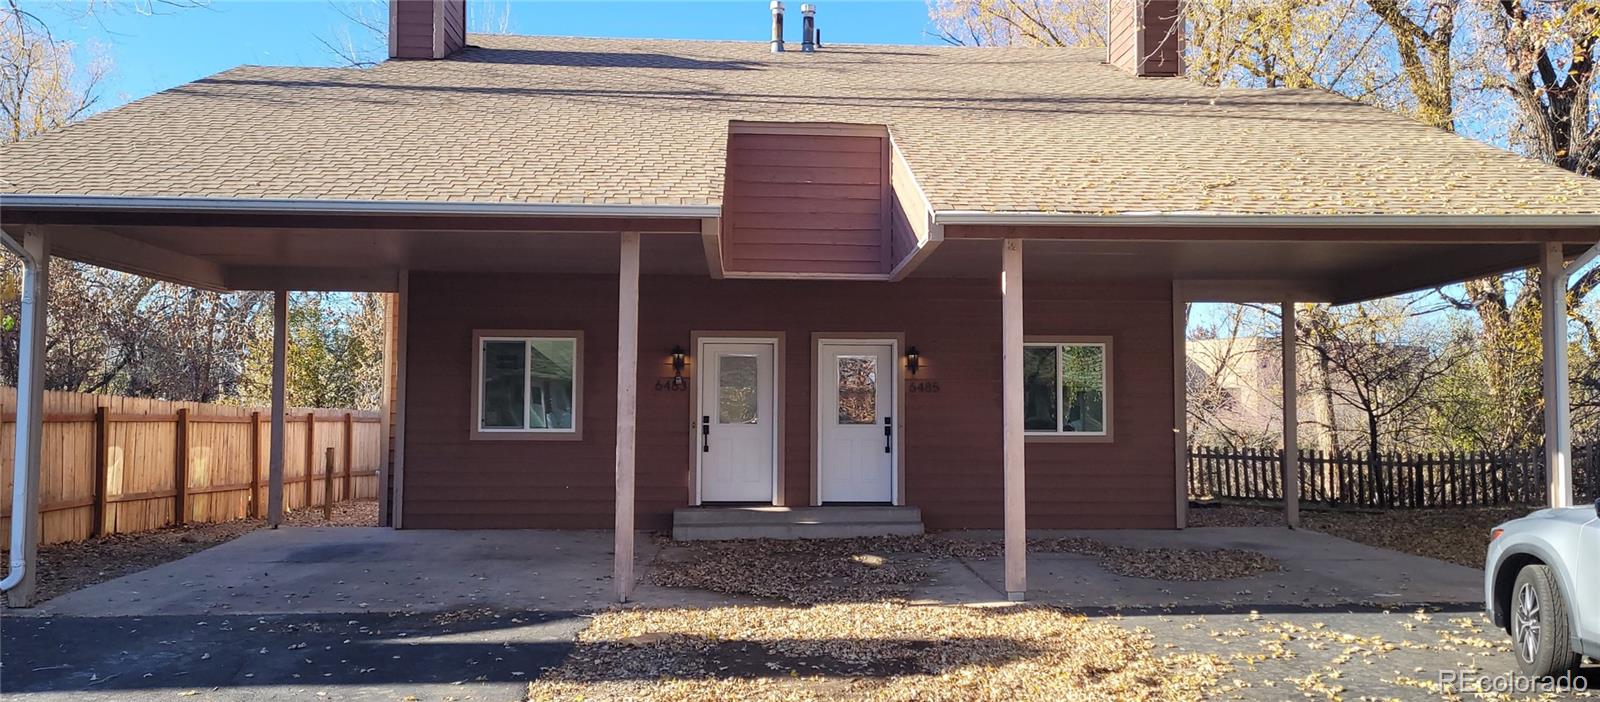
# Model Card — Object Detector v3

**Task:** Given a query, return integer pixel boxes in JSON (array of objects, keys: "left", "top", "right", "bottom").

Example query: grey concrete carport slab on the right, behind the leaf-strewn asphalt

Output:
[{"left": 912, "top": 528, "right": 1483, "bottom": 612}]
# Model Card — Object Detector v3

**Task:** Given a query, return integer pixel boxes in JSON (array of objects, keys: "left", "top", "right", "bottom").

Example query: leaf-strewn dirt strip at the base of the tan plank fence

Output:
[{"left": 0, "top": 499, "right": 378, "bottom": 603}]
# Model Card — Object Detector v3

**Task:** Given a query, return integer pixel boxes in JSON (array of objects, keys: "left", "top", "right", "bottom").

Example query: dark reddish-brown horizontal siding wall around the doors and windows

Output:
[{"left": 405, "top": 273, "right": 1176, "bottom": 529}]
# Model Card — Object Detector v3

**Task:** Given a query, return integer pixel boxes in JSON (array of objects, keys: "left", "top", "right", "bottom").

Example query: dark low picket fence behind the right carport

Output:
[{"left": 1189, "top": 445, "right": 1600, "bottom": 509}]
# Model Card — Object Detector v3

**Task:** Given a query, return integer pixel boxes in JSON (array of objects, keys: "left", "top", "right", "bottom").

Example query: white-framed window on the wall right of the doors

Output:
[{"left": 1022, "top": 339, "right": 1110, "bottom": 438}]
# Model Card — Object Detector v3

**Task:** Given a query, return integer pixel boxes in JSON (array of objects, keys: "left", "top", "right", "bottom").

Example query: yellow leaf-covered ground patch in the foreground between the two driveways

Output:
[{"left": 528, "top": 603, "right": 1229, "bottom": 700}]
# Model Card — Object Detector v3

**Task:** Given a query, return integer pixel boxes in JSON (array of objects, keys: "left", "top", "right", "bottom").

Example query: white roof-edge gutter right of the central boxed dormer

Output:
[{"left": 933, "top": 209, "right": 1600, "bottom": 229}]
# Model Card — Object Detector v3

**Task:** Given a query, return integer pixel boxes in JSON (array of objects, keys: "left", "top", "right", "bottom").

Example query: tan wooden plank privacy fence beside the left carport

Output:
[{"left": 0, "top": 387, "right": 386, "bottom": 544}]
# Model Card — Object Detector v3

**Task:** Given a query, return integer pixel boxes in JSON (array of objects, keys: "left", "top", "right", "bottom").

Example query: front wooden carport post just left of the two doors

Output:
[{"left": 611, "top": 232, "right": 638, "bottom": 601}]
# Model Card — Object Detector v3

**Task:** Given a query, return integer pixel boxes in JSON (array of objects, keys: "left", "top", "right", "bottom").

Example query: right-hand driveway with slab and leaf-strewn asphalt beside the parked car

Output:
[{"left": 914, "top": 528, "right": 1600, "bottom": 700}]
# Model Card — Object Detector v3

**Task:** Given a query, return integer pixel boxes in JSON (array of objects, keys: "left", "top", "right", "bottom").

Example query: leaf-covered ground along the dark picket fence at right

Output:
[{"left": 1189, "top": 505, "right": 1533, "bottom": 568}]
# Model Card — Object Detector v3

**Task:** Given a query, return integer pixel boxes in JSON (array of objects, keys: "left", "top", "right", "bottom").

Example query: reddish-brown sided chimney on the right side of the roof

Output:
[{"left": 1106, "top": 0, "right": 1184, "bottom": 77}]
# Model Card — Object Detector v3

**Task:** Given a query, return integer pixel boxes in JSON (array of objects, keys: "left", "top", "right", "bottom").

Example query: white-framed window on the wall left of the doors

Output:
[{"left": 472, "top": 331, "right": 582, "bottom": 438}]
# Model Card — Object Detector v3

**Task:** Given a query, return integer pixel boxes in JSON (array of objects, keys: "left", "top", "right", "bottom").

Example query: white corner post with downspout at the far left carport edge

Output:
[{"left": 5, "top": 232, "right": 50, "bottom": 608}]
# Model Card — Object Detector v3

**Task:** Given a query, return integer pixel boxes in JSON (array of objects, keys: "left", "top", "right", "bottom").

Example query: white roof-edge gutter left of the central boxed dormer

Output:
[{"left": 0, "top": 193, "right": 722, "bottom": 219}]
